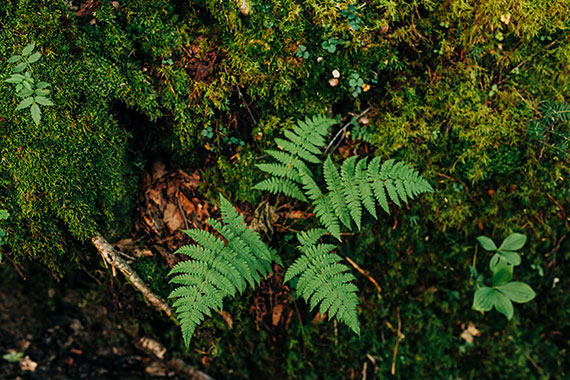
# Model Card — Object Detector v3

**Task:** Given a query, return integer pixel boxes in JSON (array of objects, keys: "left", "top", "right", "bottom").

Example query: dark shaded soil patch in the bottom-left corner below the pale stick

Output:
[{"left": 0, "top": 266, "right": 184, "bottom": 379}]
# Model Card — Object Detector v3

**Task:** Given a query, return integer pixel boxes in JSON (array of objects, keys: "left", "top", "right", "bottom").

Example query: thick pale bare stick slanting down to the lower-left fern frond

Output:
[{"left": 91, "top": 235, "right": 178, "bottom": 324}]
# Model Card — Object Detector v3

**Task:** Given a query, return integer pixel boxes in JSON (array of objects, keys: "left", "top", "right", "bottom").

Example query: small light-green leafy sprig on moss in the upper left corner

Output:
[{"left": 5, "top": 43, "right": 53, "bottom": 125}]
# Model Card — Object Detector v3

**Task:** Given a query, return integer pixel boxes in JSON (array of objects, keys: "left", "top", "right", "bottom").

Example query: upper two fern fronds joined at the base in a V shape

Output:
[{"left": 255, "top": 117, "right": 433, "bottom": 240}]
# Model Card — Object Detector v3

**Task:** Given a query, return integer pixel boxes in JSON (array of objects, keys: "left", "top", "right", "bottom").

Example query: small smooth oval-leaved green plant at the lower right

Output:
[{"left": 471, "top": 233, "right": 536, "bottom": 320}]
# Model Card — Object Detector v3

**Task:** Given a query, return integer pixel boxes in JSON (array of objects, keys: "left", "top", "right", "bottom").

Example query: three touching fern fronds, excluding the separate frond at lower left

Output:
[{"left": 255, "top": 118, "right": 433, "bottom": 333}]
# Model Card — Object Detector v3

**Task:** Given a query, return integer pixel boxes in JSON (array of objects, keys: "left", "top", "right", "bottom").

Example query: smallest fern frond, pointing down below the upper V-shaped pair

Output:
[{"left": 284, "top": 229, "right": 360, "bottom": 335}]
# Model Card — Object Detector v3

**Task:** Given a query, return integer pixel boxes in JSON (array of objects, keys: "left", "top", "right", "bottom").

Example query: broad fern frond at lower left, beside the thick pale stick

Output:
[{"left": 170, "top": 196, "right": 281, "bottom": 346}]
